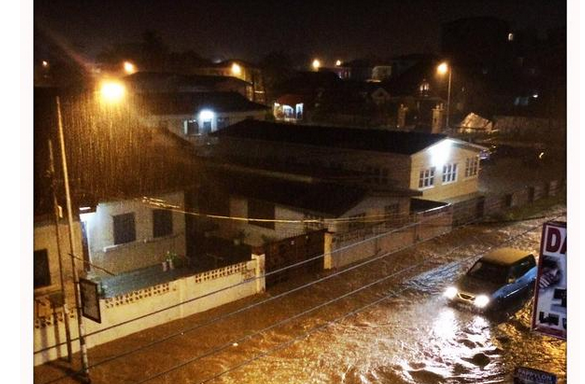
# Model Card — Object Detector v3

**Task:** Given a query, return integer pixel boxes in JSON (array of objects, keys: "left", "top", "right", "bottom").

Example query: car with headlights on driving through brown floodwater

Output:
[{"left": 444, "top": 248, "right": 537, "bottom": 311}]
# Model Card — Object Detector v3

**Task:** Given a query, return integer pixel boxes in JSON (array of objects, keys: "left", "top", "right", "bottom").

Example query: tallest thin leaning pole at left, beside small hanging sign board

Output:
[{"left": 56, "top": 96, "right": 91, "bottom": 383}]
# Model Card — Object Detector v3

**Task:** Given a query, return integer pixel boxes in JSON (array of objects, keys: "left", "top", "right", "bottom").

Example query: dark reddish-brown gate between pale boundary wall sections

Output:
[{"left": 264, "top": 230, "right": 326, "bottom": 288}]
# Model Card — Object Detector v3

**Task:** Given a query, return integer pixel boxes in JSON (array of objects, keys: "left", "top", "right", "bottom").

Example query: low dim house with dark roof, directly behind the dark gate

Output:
[{"left": 197, "top": 164, "right": 411, "bottom": 246}]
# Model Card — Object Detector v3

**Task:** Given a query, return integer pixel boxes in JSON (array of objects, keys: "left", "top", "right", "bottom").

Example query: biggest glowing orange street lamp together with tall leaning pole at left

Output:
[{"left": 56, "top": 82, "right": 125, "bottom": 382}]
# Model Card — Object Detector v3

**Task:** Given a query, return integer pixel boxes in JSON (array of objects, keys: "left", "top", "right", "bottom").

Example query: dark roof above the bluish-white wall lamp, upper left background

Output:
[{"left": 136, "top": 92, "right": 269, "bottom": 115}]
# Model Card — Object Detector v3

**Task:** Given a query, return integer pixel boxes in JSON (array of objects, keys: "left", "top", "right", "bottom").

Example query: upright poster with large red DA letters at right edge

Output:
[{"left": 532, "top": 221, "right": 567, "bottom": 340}]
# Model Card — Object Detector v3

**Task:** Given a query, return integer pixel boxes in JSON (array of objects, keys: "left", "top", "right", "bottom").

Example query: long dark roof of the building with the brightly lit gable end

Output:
[{"left": 212, "top": 120, "right": 447, "bottom": 155}]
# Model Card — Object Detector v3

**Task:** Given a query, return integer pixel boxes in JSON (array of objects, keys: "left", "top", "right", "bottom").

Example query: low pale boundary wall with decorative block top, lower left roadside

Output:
[{"left": 34, "top": 255, "right": 265, "bottom": 365}]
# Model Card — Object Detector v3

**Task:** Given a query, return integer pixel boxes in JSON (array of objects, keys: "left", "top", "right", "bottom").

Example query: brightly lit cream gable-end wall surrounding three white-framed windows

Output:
[{"left": 410, "top": 141, "right": 479, "bottom": 201}]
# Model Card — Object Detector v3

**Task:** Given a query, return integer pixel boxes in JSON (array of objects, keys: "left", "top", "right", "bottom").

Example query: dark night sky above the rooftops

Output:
[{"left": 34, "top": 0, "right": 566, "bottom": 60}]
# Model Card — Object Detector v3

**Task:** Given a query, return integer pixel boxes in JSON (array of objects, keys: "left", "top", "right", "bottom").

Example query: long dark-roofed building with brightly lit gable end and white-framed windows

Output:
[{"left": 212, "top": 121, "right": 483, "bottom": 201}]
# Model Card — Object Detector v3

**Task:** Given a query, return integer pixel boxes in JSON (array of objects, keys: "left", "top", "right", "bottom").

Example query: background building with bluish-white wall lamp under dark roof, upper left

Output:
[{"left": 135, "top": 92, "right": 270, "bottom": 144}]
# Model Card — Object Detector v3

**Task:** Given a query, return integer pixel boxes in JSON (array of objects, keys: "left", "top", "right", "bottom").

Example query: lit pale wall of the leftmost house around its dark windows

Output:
[{"left": 81, "top": 192, "right": 186, "bottom": 275}]
